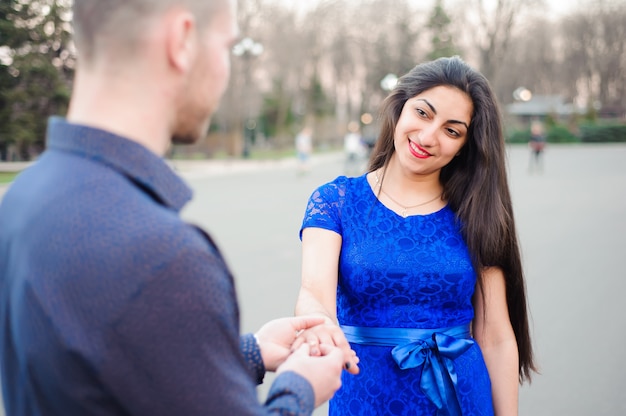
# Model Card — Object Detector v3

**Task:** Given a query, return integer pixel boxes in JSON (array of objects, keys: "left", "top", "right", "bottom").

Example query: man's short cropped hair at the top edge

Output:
[{"left": 72, "top": 0, "right": 228, "bottom": 61}]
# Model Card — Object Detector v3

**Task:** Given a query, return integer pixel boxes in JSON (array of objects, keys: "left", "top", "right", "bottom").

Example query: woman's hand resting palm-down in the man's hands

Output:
[{"left": 292, "top": 319, "right": 359, "bottom": 374}]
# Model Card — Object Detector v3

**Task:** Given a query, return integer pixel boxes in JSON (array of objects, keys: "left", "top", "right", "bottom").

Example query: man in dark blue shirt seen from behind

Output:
[{"left": 0, "top": 0, "right": 356, "bottom": 416}]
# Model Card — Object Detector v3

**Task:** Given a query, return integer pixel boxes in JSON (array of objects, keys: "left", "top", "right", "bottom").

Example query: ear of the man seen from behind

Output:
[{"left": 165, "top": 10, "right": 197, "bottom": 72}]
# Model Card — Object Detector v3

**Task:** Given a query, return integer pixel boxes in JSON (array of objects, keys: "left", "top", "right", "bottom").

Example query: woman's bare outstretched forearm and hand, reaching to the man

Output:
[{"left": 293, "top": 228, "right": 359, "bottom": 374}]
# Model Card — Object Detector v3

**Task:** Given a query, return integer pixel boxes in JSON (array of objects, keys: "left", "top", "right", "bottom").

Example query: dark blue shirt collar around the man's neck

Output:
[{"left": 46, "top": 117, "right": 192, "bottom": 211}]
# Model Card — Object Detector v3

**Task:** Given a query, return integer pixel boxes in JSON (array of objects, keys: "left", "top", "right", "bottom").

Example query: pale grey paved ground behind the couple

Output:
[{"left": 0, "top": 145, "right": 626, "bottom": 416}]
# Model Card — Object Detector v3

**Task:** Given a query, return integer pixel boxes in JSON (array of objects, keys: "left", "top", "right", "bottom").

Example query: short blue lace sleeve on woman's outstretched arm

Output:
[{"left": 300, "top": 178, "right": 346, "bottom": 239}]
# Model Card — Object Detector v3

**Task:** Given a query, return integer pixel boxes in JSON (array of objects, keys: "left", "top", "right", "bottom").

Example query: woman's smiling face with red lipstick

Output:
[{"left": 394, "top": 86, "right": 473, "bottom": 175}]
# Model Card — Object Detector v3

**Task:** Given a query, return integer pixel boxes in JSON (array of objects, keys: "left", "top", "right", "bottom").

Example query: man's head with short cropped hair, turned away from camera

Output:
[{"left": 73, "top": 0, "right": 237, "bottom": 143}]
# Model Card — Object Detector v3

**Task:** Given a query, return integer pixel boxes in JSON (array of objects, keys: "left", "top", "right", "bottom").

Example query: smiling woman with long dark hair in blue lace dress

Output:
[{"left": 296, "top": 57, "right": 535, "bottom": 415}]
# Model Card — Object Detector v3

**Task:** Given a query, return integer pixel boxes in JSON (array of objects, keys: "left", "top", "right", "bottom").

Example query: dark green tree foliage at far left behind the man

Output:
[{"left": 0, "top": 0, "right": 74, "bottom": 160}]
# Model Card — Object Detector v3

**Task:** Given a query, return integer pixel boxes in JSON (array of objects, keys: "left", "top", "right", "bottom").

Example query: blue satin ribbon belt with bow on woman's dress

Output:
[{"left": 341, "top": 325, "right": 474, "bottom": 416}]
